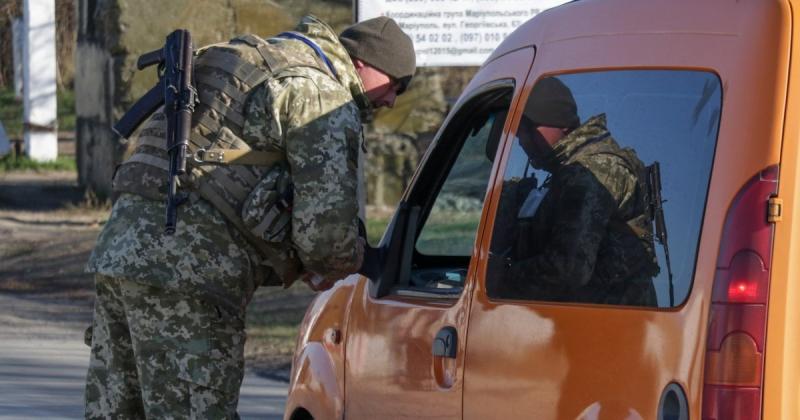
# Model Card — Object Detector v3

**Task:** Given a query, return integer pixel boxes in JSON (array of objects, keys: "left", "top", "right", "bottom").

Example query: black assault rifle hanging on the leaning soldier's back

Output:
[{"left": 114, "top": 29, "right": 197, "bottom": 235}]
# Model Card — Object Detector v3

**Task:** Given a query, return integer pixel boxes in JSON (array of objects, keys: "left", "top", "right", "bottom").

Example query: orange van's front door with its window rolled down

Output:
[{"left": 345, "top": 48, "right": 533, "bottom": 419}]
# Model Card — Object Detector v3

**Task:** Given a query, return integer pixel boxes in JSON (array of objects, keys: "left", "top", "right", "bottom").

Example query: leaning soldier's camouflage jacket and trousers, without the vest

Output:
[{"left": 86, "top": 17, "right": 369, "bottom": 418}]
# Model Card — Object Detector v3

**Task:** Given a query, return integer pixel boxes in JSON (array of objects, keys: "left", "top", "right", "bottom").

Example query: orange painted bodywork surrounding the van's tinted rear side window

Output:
[{"left": 464, "top": 0, "right": 791, "bottom": 419}]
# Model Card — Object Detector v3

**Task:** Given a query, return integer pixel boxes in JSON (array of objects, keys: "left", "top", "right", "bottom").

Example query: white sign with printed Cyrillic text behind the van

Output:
[{"left": 356, "top": 0, "right": 567, "bottom": 66}]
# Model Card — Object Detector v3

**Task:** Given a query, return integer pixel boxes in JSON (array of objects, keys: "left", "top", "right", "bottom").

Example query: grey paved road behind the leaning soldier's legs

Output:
[{"left": 0, "top": 294, "right": 287, "bottom": 420}]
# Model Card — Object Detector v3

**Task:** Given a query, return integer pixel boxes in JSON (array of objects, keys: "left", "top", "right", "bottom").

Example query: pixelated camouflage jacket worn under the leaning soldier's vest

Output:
[{"left": 87, "top": 17, "right": 370, "bottom": 310}]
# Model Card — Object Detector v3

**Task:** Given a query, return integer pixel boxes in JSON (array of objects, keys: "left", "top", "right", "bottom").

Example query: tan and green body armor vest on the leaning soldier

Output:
[{"left": 113, "top": 35, "right": 330, "bottom": 286}]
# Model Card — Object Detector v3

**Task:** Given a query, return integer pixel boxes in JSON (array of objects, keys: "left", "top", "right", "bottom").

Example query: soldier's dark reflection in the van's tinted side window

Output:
[{"left": 504, "top": 77, "right": 658, "bottom": 306}]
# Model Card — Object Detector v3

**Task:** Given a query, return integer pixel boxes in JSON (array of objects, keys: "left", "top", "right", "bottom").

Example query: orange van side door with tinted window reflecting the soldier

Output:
[{"left": 464, "top": 69, "right": 722, "bottom": 419}]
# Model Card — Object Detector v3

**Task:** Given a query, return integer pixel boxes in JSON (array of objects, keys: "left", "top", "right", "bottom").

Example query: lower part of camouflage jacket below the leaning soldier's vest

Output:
[{"left": 87, "top": 194, "right": 257, "bottom": 311}]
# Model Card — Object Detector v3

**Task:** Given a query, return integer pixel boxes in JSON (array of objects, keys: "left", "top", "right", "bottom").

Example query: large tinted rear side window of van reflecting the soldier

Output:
[{"left": 486, "top": 70, "right": 722, "bottom": 307}]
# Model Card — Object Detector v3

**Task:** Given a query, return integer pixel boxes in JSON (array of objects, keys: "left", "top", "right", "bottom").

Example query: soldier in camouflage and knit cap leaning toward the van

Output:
[{"left": 86, "top": 17, "right": 415, "bottom": 419}]
